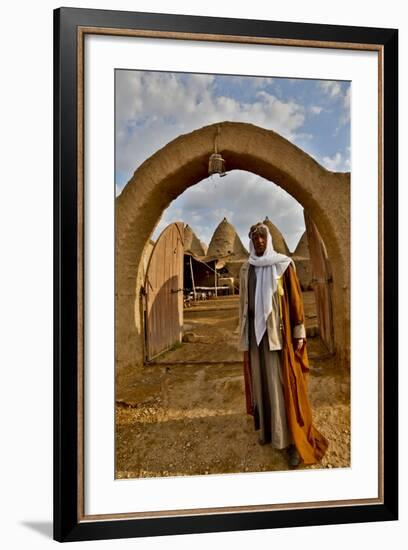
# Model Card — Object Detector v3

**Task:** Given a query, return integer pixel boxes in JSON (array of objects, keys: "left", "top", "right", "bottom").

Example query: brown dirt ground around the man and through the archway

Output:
[{"left": 115, "top": 292, "right": 350, "bottom": 478}]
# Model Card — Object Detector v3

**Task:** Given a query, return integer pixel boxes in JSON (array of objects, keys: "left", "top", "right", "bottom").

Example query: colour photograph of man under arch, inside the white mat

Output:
[{"left": 115, "top": 69, "right": 352, "bottom": 479}]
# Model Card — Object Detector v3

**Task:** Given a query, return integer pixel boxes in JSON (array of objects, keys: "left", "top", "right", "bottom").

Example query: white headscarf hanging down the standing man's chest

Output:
[{"left": 248, "top": 224, "right": 293, "bottom": 345}]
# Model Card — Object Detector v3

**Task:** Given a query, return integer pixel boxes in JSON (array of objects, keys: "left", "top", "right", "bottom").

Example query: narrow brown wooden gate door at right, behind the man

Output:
[{"left": 304, "top": 211, "right": 334, "bottom": 353}]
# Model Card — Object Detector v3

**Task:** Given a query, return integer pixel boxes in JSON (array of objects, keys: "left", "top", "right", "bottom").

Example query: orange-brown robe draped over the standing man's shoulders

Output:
[{"left": 244, "top": 265, "right": 328, "bottom": 464}]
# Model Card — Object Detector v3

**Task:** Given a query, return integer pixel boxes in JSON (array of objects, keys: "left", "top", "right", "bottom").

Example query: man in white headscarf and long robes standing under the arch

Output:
[{"left": 239, "top": 223, "right": 328, "bottom": 467}]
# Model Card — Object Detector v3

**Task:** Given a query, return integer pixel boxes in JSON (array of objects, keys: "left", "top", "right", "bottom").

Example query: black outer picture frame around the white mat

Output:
[{"left": 54, "top": 8, "right": 398, "bottom": 542}]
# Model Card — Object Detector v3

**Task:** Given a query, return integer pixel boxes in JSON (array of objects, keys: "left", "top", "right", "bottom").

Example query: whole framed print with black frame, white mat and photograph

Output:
[{"left": 54, "top": 8, "right": 398, "bottom": 541}]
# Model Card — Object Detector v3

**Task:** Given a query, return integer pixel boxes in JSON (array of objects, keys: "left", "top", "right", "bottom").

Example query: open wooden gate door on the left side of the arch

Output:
[{"left": 144, "top": 222, "right": 184, "bottom": 361}]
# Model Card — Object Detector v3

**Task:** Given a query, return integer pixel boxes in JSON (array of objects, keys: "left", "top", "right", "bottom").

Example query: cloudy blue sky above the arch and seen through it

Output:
[{"left": 115, "top": 70, "right": 351, "bottom": 250}]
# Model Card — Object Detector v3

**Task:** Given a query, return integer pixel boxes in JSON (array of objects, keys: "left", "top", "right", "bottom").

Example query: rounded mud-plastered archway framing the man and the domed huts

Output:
[{"left": 115, "top": 122, "right": 350, "bottom": 374}]
